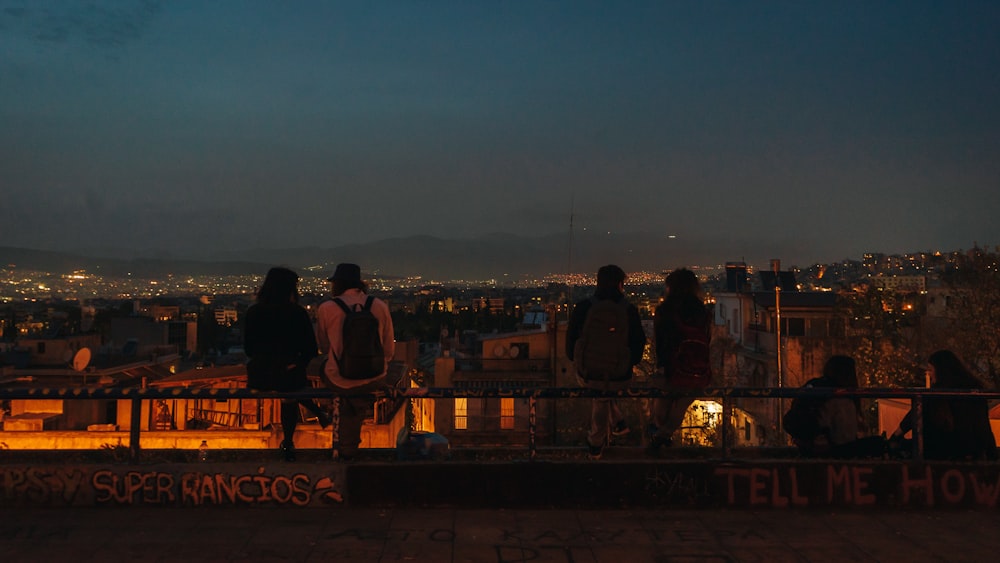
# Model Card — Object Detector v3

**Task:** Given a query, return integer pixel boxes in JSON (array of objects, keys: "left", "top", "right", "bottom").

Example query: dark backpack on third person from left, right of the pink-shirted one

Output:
[{"left": 573, "top": 299, "right": 632, "bottom": 381}]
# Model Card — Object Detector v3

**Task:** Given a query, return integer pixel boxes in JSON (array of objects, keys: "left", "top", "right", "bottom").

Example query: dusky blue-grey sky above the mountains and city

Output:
[{"left": 0, "top": 0, "right": 1000, "bottom": 268}]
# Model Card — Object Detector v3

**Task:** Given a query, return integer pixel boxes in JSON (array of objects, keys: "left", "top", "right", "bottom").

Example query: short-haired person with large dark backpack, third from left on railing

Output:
[{"left": 566, "top": 264, "right": 646, "bottom": 459}]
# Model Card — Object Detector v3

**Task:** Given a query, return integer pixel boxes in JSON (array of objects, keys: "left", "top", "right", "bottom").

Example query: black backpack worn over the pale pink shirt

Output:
[{"left": 334, "top": 295, "right": 385, "bottom": 379}]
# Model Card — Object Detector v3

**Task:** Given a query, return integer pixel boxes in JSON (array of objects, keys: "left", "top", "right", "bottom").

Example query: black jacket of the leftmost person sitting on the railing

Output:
[{"left": 243, "top": 302, "right": 318, "bottom": 391}]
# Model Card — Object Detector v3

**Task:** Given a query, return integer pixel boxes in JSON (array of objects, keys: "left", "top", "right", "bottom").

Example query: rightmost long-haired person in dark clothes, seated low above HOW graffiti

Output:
[{"left": 890, "top": 350, "right": 997, "bottom": 460}]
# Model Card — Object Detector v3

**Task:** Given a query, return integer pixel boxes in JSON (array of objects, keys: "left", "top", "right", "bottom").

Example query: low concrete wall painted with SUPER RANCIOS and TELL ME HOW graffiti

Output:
[{"left": 0, "top": 460, "right": 1000, "bottom": 510}]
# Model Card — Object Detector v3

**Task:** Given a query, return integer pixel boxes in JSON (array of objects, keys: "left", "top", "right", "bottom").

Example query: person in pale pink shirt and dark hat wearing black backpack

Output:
[{"left": 316, "top": 263, "right": 395, "bottom": 459}]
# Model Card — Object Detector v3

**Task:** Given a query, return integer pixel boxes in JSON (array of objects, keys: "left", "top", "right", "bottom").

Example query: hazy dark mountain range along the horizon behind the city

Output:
[{"left": 0, "top": 232, "right": 842, "bottom": 281}]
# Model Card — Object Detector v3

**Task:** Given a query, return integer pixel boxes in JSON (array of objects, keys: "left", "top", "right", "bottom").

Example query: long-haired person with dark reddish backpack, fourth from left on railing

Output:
[{"left": 647, "top": 268, "right": 712, "bottom": 456}]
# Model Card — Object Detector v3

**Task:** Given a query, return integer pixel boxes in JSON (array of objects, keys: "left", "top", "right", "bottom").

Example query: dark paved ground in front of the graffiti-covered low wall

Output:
[{"left": 0, "top": 506, "right": 1000, "bottom": 563}]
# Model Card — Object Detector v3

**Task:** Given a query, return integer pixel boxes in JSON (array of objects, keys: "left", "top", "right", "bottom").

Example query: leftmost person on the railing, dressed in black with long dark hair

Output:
[{"left": 243, "top": 267, "right": 330, "bottom": 461}]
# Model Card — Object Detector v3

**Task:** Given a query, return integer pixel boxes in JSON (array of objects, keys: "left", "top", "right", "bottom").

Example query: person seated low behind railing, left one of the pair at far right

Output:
[{"left": 782, "top": 355, "right": 886, "bottom": 458}]
